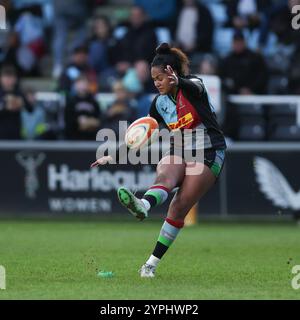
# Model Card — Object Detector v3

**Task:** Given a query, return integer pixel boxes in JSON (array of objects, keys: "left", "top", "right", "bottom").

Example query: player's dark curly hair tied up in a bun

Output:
[{"left": 151, "top": 42, "right": 190, "bottom": 76}]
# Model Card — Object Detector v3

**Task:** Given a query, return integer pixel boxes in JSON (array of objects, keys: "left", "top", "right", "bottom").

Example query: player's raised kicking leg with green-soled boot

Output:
[{"left": 118, "top": 156, "right": 185, "bottom": 220}]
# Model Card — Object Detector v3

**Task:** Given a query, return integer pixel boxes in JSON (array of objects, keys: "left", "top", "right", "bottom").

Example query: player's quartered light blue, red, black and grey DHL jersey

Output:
[{"left": 149, "top": 75, "right": 226, "bottom": 149}]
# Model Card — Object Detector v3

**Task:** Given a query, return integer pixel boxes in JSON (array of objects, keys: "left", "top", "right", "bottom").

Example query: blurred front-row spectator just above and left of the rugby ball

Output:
[{"left": 105, "top": 81, "right": 136, "bottom": 135}]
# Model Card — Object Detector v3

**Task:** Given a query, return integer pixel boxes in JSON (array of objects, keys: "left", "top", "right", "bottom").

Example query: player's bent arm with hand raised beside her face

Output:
[{"left": 165, "top": 66, "right": 205, "bottom": 95}]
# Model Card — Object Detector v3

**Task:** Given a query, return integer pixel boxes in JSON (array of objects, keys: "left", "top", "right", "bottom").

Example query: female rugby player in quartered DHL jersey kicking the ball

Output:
[{"left": 92, "top": 43, "right": 226, "bottom": 278}]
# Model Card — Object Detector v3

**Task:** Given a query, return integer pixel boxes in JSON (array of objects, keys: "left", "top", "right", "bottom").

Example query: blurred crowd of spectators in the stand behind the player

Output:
[{"left": 0, "top": 0, "right": 300, "bottom": 140}]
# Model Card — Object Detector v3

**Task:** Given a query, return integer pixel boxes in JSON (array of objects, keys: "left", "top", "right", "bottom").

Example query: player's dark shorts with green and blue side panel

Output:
[{"left": 164, "top": 144, "right": 225, "bottom": 178}]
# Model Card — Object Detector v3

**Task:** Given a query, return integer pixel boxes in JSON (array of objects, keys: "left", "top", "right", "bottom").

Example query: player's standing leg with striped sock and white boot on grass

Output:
[{"left": 140, "top": 163, "right": 216, "bottom": 277}]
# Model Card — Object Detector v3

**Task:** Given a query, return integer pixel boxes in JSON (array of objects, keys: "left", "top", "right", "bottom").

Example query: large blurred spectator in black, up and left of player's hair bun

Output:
[{"left": 116, "top": 6, "right": 157, "bottom": 74}]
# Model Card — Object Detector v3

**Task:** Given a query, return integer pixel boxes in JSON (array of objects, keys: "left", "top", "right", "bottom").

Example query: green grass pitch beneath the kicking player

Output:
[{"left": 0, "top": 221, "right": 300, "bottom": 299}]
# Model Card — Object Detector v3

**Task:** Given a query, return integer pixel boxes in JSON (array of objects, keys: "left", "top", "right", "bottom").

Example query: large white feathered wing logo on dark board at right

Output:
[{"left": 254, "top": 157, "right": 300, "bottom": 211}]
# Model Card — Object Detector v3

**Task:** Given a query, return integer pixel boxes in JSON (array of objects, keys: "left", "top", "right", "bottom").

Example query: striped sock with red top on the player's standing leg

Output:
[{"left": 146, "top": 218, "right": 184, "bottom": 267}]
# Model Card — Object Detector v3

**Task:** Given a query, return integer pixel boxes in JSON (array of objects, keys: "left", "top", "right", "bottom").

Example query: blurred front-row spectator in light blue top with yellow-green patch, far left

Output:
[{"left": 21, "top": 88, "right": 47, "bottom": 140}]
